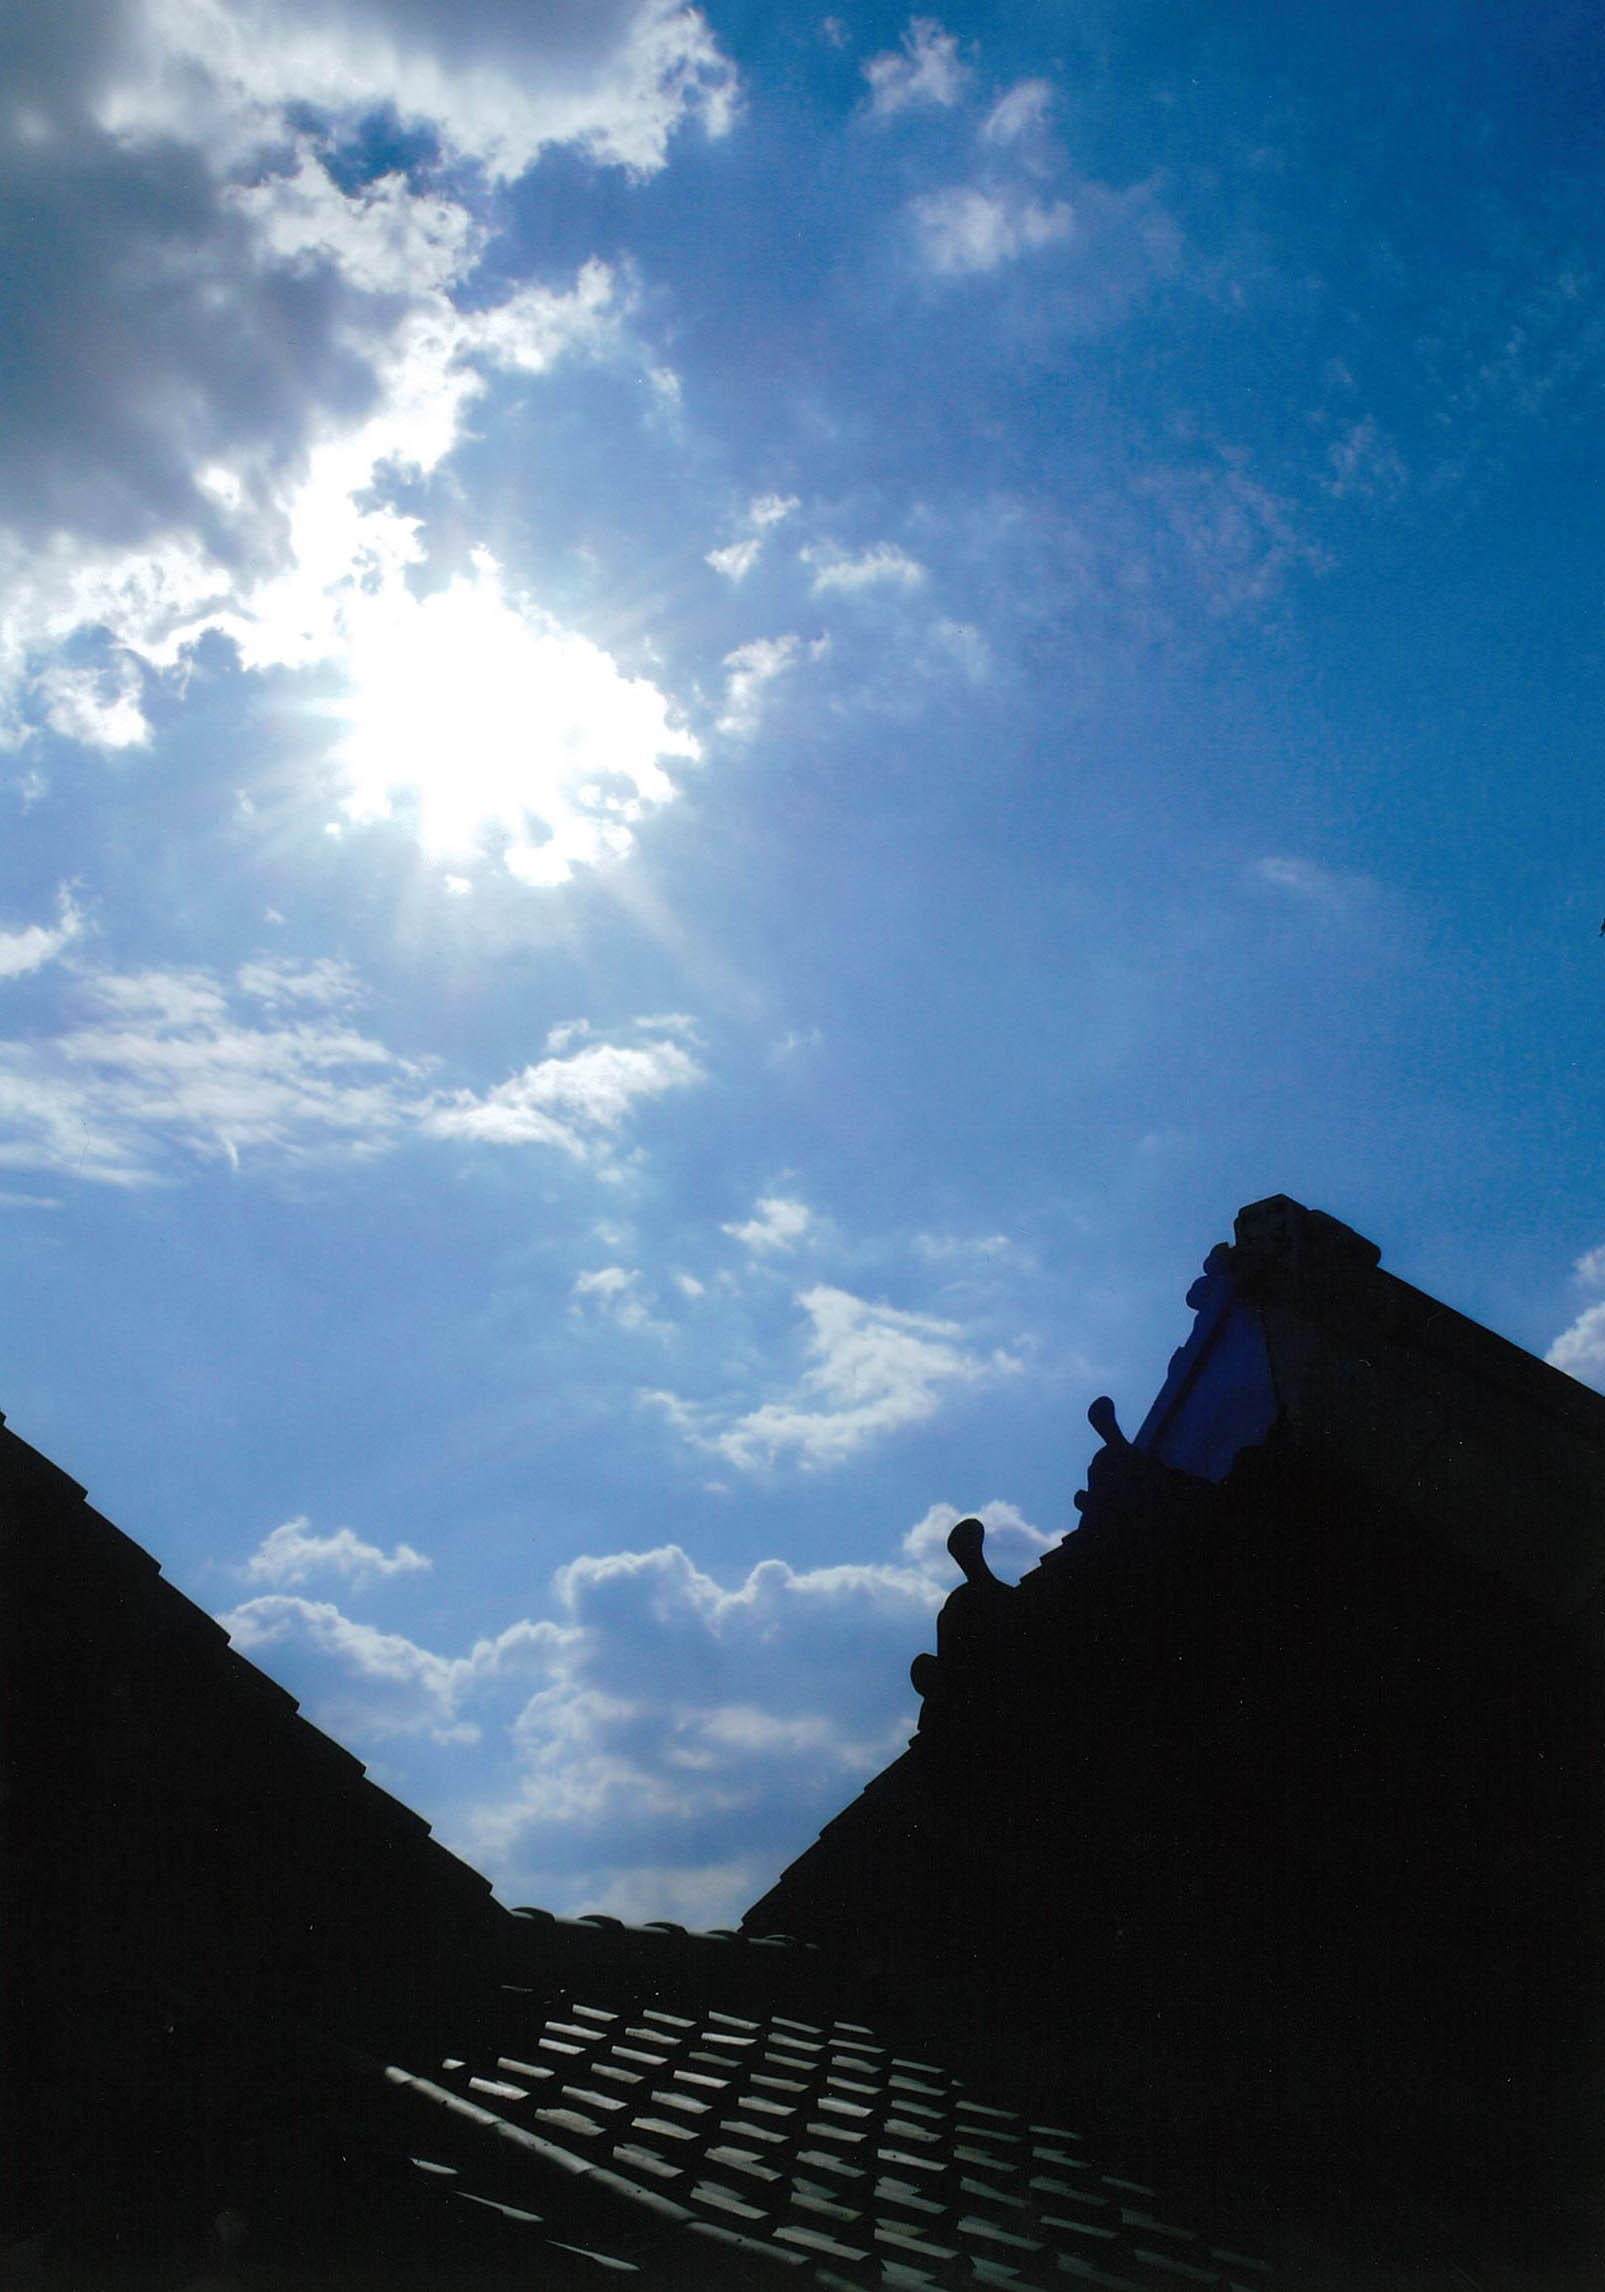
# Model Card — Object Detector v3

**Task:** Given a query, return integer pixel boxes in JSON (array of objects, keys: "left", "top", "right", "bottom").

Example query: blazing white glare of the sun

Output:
[{"left": 339, "top": 552, "right": 699, "bottom": 885}]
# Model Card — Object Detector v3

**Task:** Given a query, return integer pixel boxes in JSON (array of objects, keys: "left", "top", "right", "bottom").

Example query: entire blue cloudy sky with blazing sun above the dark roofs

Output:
[{"left": 0, "top": 0, "right": 1605, "bottom": 1925}]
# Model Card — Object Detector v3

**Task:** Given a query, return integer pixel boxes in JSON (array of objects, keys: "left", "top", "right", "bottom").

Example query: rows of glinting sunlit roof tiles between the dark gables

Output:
[{"left": 390, "top": 1992, "right": 1270, "bottom": 2292}]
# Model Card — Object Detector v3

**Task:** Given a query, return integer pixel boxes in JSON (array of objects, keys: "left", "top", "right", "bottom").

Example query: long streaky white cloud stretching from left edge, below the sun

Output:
[{"left": 0, "top": 963, "right": 702, "bottom": 1185}]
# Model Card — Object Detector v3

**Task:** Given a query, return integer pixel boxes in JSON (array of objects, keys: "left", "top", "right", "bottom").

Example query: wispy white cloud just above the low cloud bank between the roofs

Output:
[{"left": 642, "top": 1284, "right": 1020, "bottom": 1471}]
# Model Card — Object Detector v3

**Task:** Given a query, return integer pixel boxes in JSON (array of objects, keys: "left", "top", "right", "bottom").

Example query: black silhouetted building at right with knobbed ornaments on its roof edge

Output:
[{"left": 747, "top": 1199, "right": 1605, "bottom": 2285}]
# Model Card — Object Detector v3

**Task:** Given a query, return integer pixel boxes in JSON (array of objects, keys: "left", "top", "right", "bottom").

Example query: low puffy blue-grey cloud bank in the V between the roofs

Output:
[{"left": 220, "top": 1504, "right": 990, "bottom": 1923}]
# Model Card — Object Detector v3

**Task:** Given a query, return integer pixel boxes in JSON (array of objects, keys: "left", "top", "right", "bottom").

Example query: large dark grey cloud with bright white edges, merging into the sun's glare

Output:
[{"left": 0, "top": 0, "right": 734, "bottom": 885}]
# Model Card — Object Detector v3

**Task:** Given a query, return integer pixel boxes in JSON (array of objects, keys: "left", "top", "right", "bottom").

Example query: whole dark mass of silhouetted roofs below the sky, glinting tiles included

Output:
[{"left": 0, "top": 1199, "right": 1605, "bottom": 2292}]
